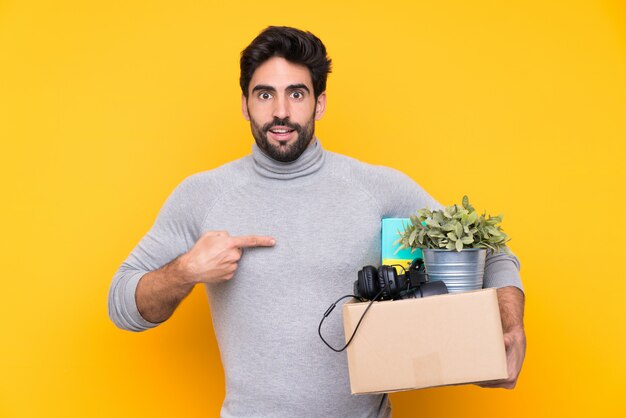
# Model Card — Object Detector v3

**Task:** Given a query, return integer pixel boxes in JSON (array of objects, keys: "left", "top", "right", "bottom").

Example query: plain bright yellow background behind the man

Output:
[{"left": 0, "top": 0, "right": 626, "bottom": 417}]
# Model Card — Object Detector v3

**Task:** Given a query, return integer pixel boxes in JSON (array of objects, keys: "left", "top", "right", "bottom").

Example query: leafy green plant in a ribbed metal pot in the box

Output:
[{"left": 396, "top": 196, "right": 510, "bottom": 293}]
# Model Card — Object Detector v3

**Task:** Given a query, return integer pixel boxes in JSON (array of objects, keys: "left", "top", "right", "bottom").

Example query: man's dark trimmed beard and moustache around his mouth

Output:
[{"left": 250, "top": 114, "right": 315, "bottom": 163}]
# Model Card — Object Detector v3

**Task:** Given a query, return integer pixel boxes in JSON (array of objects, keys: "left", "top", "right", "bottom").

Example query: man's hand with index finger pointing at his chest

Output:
[{"left": 180, "top": 231, "right": 276, "bottom": 284}]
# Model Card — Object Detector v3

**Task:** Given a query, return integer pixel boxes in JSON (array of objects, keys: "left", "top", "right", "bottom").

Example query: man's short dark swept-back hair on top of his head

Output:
[{"left": 239, "top": 26, "right": 331, "bottom": 98}]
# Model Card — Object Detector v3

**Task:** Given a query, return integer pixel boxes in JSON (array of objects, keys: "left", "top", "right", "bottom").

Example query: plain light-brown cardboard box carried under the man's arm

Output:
[{"left": 343, "top": 289, "right": 507, "bottom": 394}]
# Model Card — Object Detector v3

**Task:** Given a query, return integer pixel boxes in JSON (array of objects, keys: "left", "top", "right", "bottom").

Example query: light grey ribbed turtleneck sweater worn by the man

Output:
[{"left": 109, "top": 140, "right": 521, "bottom": 418}]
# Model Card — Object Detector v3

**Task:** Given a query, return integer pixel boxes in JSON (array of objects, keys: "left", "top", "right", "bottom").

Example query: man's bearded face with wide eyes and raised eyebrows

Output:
[{"left": 242, "top": 57, "right": 326, "bottom": 162}]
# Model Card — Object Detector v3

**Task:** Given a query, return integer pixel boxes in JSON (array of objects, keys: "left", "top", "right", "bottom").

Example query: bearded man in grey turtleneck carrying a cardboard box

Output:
[{"left": 109, "top": 27, "right": 525, "bottom": 417}]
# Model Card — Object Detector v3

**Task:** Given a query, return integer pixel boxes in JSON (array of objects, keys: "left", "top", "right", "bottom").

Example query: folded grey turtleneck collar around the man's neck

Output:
[{"left": 252, "top": 138, "right": 324, "bottom": 180}]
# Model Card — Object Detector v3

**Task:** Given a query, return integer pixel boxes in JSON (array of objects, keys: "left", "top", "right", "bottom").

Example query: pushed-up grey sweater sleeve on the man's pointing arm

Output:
[{"left": 108, "top": 177, "right": 212, "bottom": 331}]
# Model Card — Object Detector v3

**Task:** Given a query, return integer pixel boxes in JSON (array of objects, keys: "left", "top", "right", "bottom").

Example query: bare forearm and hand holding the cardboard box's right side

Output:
[{"left": 478, "top": 286, "right": 526, "bottom": 389}]
